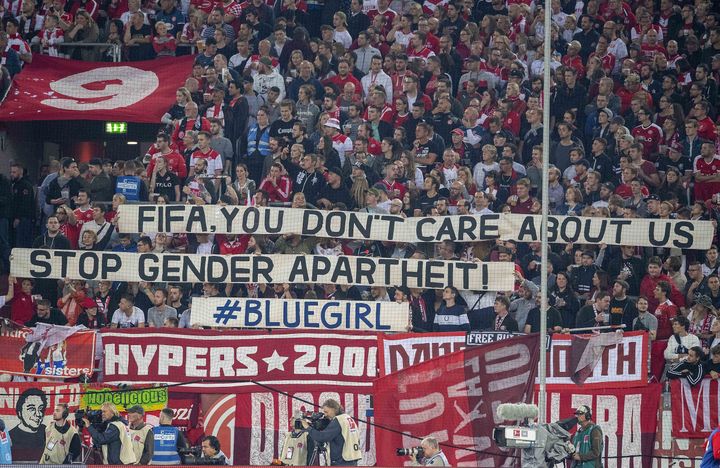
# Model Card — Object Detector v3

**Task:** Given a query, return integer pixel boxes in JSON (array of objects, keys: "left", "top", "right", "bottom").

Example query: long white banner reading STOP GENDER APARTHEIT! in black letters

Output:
[{"left": 10, "top": 249, "right": 515, "bottom": 291}]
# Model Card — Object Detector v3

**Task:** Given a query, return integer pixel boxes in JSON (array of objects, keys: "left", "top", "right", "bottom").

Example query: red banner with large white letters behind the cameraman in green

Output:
[{"left": 536, "top": 384, "right": 662, "bottom": 468}]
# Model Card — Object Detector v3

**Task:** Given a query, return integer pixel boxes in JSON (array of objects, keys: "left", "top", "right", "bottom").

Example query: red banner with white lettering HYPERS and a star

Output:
[{"left": 103, "top": 329, "right": 377, "bottom": 393}]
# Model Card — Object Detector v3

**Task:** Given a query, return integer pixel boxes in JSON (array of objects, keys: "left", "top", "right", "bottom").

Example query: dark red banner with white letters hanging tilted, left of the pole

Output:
[{"left": 374, "top": 334, "right": 539, "bottom": 466}]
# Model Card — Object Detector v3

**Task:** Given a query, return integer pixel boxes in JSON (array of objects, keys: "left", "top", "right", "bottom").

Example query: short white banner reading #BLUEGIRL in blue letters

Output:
[{"left": 190, "top": 297, "right": 410, "bottom": 332}]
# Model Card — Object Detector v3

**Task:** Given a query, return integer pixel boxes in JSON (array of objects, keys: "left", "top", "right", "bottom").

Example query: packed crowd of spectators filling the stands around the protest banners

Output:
[{"left": 0, "top": 0, "right": 720, "bottom": 378}]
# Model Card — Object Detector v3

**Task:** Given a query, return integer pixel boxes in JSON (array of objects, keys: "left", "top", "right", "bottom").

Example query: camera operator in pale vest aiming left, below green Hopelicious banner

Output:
[{"left": 83, "top": 402, "right": 137, "bottom": 465}]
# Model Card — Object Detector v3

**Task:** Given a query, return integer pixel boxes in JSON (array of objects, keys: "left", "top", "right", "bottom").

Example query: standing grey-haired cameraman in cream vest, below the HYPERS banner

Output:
[{"left": 302, "top": 398, "right": 362, "bottom": 466}]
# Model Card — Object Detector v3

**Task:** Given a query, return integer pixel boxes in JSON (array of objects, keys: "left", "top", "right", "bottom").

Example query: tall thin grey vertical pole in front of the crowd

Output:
[{"left": 538, "top": 0, "right": 552, "bottom": 423}]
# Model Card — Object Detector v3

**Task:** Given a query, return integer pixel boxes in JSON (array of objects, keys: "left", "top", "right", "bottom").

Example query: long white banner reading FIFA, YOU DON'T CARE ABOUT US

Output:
[{"left": 118, "top": 205, "right": 713, "bottom": 250}]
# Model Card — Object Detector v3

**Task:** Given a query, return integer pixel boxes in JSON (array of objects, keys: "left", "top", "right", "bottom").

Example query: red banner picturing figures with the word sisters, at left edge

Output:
[{"left": 0, "top": 327, "right": 95, "bottom": 379}]
